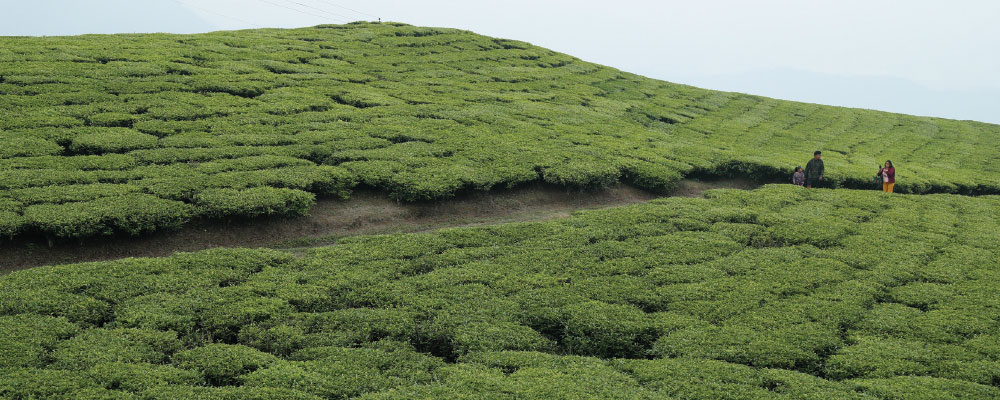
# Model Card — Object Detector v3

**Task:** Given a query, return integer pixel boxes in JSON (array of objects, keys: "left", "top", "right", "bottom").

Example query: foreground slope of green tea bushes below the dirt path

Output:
[{"left": 0, "top": 185, "right": 1000, "bottom": 399}]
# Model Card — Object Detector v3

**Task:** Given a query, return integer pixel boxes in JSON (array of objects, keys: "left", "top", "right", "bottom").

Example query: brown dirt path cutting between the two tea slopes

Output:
[{"left": 0, "top": 180, "right": 757, "bottom": 274}]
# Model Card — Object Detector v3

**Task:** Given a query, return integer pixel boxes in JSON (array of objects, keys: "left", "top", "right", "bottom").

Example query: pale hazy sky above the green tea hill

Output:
[{"left": 0, "top": 0, "right": 1000, "bottom": 123}]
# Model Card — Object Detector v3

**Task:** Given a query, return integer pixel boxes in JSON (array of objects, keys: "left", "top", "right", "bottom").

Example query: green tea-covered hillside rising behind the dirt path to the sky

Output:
[{"left": 0, "top": 23, "right": 1000, "bottom": 238}]
